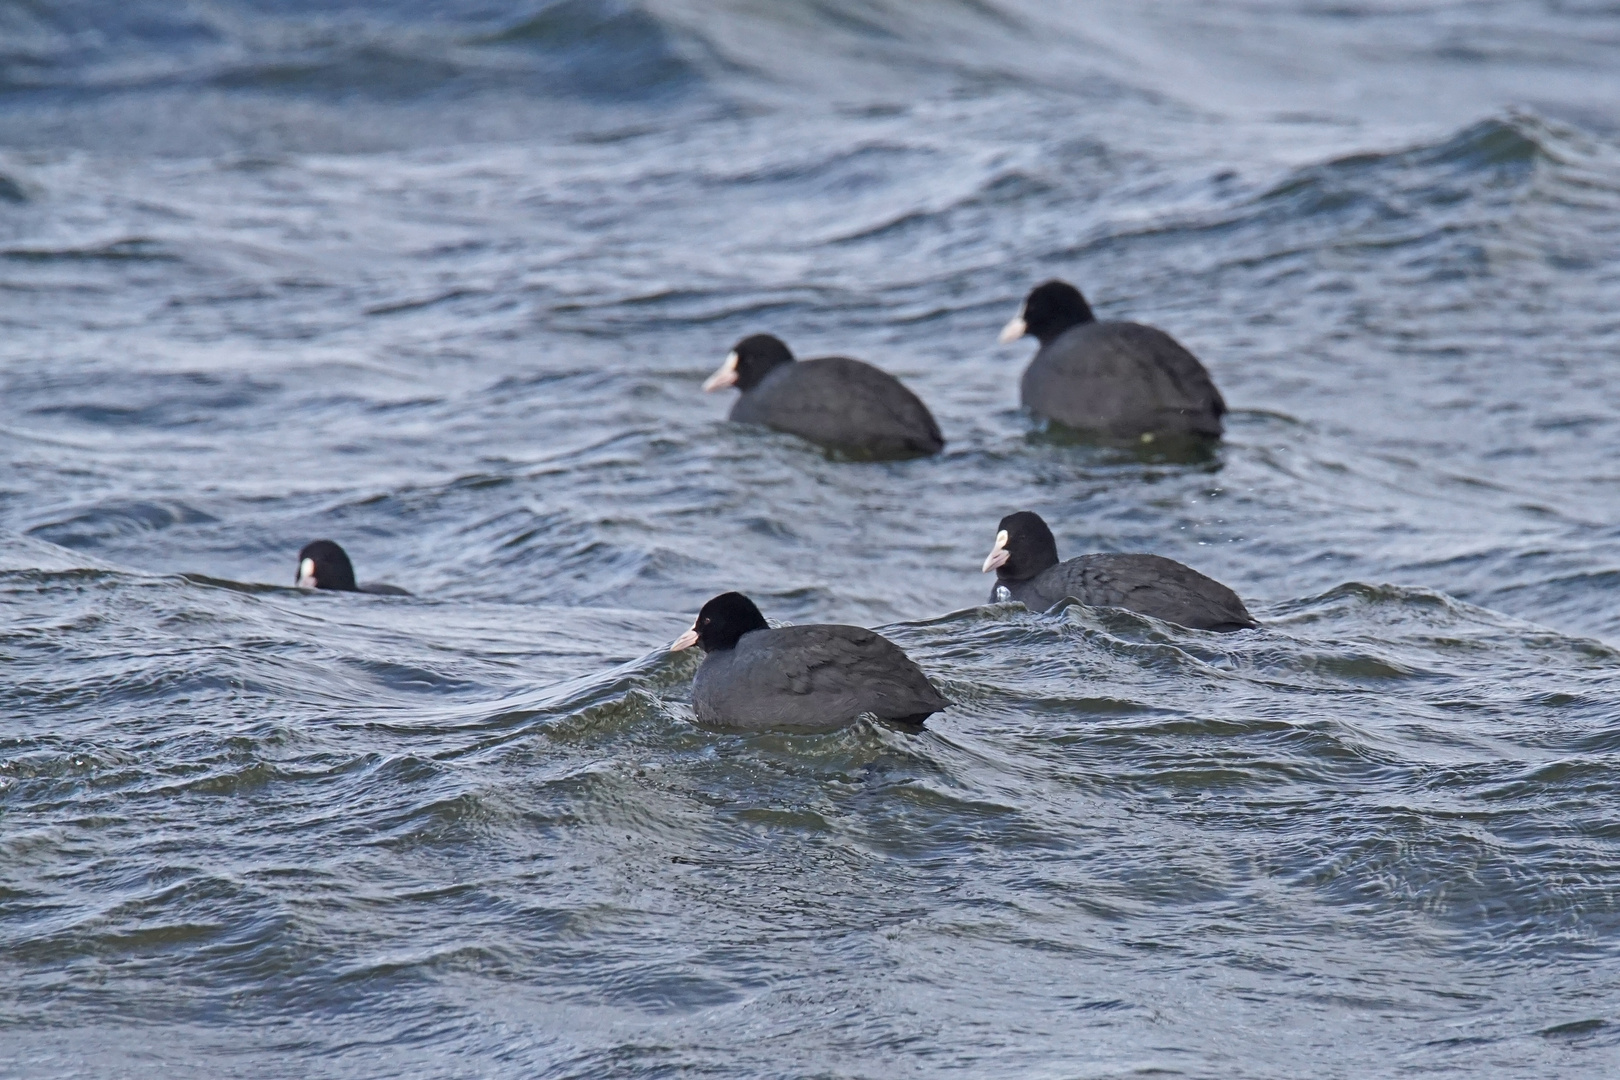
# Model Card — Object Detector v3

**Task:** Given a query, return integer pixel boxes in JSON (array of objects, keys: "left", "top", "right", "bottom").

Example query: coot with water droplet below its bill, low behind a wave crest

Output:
[{"left": 983, "top": 510, "right": 1259, "bottom": 630}]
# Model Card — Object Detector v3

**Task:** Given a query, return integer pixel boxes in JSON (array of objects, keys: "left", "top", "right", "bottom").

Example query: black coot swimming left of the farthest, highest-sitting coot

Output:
[{"left": 703, "top": 334, "right": 944, "bottom": 458}]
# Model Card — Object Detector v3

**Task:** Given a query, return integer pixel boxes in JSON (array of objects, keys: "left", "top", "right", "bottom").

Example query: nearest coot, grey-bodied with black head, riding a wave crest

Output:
[{"left": 669, "top": 593, "right": 951, "bottom": 732}]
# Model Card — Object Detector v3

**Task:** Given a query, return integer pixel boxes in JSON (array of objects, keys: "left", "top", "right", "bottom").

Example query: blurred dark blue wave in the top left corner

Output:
[{"left": 0, "top": 0, "right": 703, "bottom": 100}]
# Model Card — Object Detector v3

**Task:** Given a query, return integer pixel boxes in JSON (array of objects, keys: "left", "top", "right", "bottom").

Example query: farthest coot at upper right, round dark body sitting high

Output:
[{"left": 1001, "top": 282, "right": 1226, "bottom": 442}]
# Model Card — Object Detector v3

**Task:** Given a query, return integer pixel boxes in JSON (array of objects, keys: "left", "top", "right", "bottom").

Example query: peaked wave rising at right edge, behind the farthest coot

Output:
[{"left": 1017, "top": 110, "right": 1620, "bottom": 293}]
